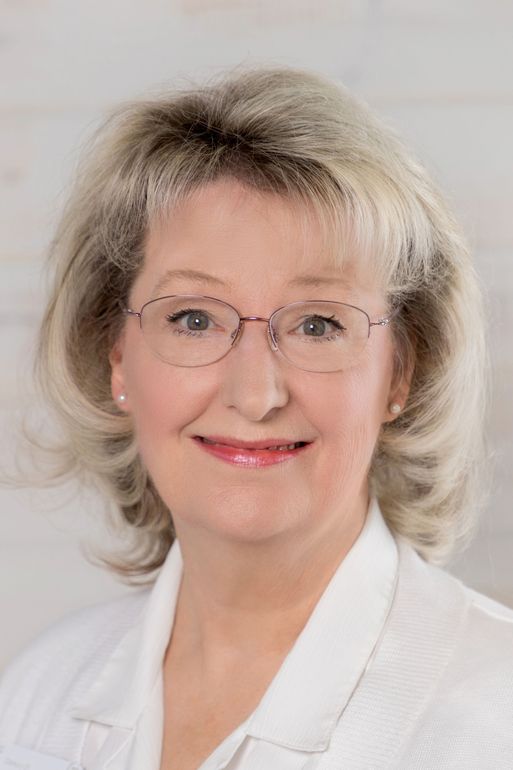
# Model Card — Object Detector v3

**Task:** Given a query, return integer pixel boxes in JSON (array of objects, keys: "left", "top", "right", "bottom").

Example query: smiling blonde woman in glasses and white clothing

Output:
[{"left": 0, "top": 68, "right": 513, "bottom": 770}]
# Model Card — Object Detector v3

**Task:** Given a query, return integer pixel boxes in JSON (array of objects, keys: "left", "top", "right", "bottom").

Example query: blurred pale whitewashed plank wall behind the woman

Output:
[{"left": 0, "top": 0, "right": 513, "bottom": 668}]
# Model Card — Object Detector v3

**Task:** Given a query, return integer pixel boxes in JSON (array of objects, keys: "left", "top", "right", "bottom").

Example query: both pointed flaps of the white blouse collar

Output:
[{"left": 71, "top": 498, "right": 398, "bottom": 751}]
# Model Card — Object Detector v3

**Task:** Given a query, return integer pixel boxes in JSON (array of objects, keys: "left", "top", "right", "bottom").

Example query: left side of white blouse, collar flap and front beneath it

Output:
[{"left": 68, "top": 540, "right": 182, "bottom": 770}]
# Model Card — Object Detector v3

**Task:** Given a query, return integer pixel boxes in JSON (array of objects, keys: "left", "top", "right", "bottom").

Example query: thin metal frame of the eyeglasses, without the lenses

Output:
[{"left": 120, "top": 294, "right": 401, "bottom": 371}]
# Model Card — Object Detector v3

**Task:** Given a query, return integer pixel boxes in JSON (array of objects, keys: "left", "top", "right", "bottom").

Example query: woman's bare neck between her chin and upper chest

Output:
[{"left": 167, "top": 492, "right": 368, "bottom": 672}]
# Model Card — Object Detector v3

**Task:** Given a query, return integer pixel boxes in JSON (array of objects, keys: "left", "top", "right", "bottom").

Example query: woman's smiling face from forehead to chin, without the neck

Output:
[{"left": 111, "top": 180, "right": 406, "bottom": 542}]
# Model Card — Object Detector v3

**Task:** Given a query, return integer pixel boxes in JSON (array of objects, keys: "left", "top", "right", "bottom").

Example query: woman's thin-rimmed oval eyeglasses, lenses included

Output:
[{"left": 123, "top": 294, "right": 399, "bottom": 372}]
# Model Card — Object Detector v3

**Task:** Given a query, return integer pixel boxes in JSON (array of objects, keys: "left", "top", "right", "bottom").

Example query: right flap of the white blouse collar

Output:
[{"left": 247, "top": 498, "right": 398, "bottom": 751}]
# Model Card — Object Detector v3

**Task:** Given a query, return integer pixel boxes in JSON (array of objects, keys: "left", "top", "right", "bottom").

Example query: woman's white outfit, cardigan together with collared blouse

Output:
[{"left": 0, "top": 499, "right": 513, "bottom": 770}]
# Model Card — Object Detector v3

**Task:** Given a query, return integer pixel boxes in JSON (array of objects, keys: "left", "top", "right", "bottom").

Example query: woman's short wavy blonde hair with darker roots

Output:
[{"left": 36, "top": 66, "right": 487, "bottom": 581}]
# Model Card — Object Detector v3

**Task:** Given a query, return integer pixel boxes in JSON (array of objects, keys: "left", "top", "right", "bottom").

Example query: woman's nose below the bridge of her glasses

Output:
[{"left": 222, "top": 316, "right": 289, "bottom": 422}]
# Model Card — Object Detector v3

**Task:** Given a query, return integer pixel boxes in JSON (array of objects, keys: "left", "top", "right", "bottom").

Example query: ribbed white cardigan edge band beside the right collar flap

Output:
[{"left": 319, "top": 538, "right": 469, "bottom": 770}]
